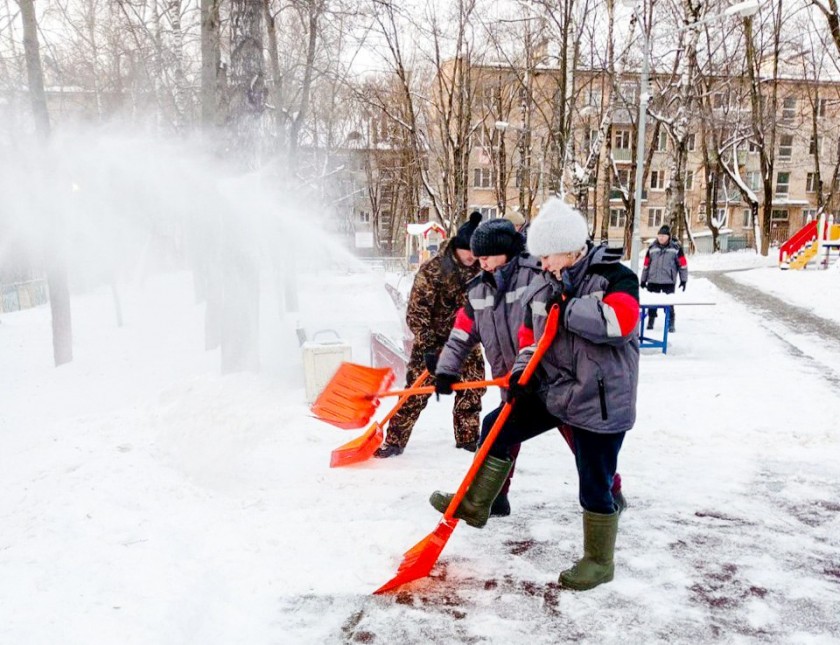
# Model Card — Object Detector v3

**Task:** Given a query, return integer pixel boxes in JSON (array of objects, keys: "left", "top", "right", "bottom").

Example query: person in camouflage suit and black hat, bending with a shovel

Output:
[{"left": 374, "top": 212, "right": 486, "bottom": 458}]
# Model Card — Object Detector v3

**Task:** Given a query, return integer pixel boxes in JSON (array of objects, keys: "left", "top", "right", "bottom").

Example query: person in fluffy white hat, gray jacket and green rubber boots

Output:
[{"left": 430, "top": 198, "right": 639, "bottom": 590}]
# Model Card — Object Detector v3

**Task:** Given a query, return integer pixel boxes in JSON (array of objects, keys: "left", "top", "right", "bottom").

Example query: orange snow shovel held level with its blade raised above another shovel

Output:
[{"left": 310, "top": 363, "right": 505, "bottom": 430}]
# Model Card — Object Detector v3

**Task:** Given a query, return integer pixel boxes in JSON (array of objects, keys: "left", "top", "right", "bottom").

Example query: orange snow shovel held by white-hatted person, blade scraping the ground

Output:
[{"left": 373, "top": 305, "right": 560, "bottom": 594}]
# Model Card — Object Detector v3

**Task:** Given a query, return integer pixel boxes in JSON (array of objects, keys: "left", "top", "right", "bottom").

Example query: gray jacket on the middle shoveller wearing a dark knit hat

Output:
[{"left": 435, "top": 254, "right": 542, "bottom": 378}]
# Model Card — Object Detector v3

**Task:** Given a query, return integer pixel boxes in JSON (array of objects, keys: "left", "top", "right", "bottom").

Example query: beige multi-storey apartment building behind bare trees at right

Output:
[{"left": 460, "top": 61, "right": 840, "bottom": 248}]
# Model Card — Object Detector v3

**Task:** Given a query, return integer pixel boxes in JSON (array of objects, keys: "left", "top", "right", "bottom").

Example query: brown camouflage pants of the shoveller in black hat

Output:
[{"left": 385, "top": 347, "right": 487, "bottom": 448}]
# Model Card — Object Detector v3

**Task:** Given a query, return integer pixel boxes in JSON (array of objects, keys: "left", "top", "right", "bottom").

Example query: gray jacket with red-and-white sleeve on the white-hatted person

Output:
[{"left": 514, "top": 245, "right": 639, "bottom": 433}]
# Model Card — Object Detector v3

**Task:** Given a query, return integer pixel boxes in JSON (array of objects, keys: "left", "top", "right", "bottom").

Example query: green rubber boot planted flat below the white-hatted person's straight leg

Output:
[{"left": 560, "top": 511, "right": 619, "bottom": 591}]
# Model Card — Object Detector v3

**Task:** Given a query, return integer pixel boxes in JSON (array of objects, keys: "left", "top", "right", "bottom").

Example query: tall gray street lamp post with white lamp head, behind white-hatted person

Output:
[{"left": 622, "top": 0, "right": 761, "bottom": 275}]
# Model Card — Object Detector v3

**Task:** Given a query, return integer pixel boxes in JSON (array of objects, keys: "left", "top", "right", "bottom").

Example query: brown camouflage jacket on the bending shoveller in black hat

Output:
[{"left": 405, "top": 236, "right": 478, "bottom": 351}]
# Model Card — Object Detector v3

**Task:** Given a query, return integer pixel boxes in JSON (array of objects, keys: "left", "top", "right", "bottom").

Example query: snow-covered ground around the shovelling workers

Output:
[{"left": 0, "top": 254, "right": 840, "bottom": 645}]
